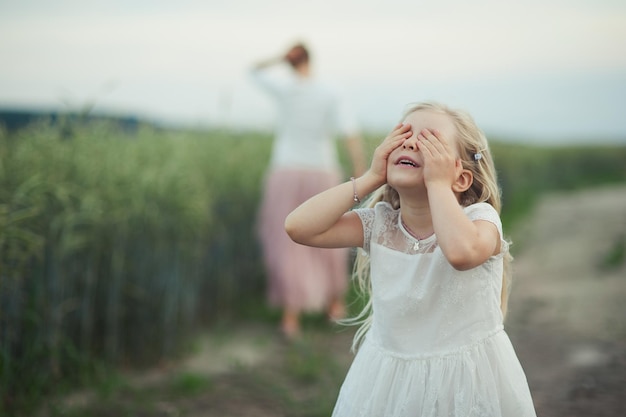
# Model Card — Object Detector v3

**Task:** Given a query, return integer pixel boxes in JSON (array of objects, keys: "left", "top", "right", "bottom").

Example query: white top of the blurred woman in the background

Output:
[{"left": 252, "top": 69, "right": 357, "bottom": 170}]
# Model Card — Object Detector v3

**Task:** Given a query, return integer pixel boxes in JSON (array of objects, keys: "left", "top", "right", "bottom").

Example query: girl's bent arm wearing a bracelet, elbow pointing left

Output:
[{"left": 285, "top": 125, "right": 412, "bottom": 248}]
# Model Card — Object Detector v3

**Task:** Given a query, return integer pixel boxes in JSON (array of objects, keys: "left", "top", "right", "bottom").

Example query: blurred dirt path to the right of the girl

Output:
[{"left": 507, "top": 187, "right": 626, "bottom": 417}]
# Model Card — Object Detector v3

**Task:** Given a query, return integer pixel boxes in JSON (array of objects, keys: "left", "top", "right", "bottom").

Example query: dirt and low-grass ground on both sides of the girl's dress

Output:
[{"left": 43, "top": 186, "right": 626, "bottom": 417}]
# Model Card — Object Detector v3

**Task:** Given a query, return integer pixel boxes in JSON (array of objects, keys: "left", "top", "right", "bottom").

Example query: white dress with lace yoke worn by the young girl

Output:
[{"left": 333, "top": 203, "right": 536, "bottom": 417}]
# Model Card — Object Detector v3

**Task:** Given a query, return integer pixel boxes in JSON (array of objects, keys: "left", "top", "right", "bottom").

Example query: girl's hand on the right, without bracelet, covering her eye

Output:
[{"left": 417, "top": 129, "right": 463, "bottom": 187}]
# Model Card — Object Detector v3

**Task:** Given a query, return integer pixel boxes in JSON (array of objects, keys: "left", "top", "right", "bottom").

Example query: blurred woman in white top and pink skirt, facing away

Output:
[{"left": 252, "top": 44, "right": 365, "bottom": 338}]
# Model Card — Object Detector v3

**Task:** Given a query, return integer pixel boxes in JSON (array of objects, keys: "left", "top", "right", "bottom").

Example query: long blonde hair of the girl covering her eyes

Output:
[{"left": 343, "top": 103, "right": 512, "bottom": 349}]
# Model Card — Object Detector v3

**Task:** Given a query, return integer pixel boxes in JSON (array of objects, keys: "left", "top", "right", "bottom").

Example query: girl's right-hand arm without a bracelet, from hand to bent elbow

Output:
[{"left": 418, "top": 130, "right": 500, "bottom": 270}]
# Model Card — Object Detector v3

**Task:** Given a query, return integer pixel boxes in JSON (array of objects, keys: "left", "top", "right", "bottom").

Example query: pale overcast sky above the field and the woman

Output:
[{"left": 0, "top": 0, "right": 626, "bottom": 143}]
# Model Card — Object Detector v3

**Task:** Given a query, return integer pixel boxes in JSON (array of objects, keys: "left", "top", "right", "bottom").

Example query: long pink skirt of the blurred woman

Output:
[{"left": 259, "top": 169, "right": 349, "bottom": 312}]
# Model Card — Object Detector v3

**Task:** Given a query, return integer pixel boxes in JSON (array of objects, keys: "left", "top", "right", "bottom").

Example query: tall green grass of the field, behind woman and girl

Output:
[{"left": 0, "top": 119, "right": 626, "bottom": 414}]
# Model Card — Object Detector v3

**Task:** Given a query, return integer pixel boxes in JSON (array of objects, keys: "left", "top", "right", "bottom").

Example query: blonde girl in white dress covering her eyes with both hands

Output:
[{"left": 285, "top": 103, "right": 535, "bottom": 417}]
